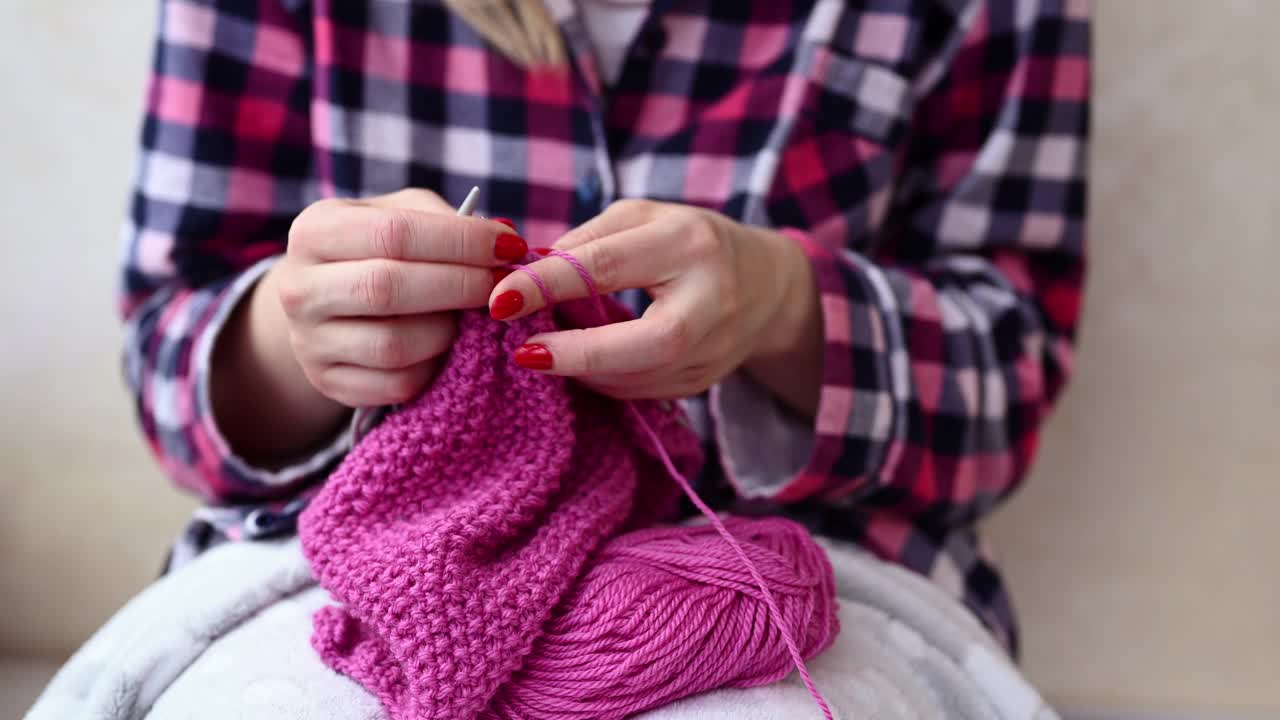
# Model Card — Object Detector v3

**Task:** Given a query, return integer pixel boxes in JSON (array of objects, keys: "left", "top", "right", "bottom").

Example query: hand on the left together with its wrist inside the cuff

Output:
[{"left": 211, "top": 190, "right": 529, "bottom": 461}]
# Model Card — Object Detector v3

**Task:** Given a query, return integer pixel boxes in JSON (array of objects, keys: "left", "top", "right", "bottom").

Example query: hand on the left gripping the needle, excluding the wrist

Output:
[{"left": 260, "top": 190, "right": 529, "bottom": 407}]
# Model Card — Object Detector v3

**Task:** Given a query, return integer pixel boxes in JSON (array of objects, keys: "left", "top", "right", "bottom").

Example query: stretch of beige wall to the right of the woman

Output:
[{"left": 995, "top": 0, "right": 1280, "bottom": 717}]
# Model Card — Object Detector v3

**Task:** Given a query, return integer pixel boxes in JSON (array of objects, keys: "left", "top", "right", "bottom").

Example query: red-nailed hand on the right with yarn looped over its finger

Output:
[{"left": 489, "top": 200, "right": 817, "bottom": 400}]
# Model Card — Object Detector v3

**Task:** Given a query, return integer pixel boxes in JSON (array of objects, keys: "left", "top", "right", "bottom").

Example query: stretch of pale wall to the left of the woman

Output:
[{"left": 0, "top": 0, "right": 197, "bottom": 652}]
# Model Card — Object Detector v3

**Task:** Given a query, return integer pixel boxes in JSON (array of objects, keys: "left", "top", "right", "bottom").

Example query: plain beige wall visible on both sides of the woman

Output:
[{"left": 0, "top": 0, "right": 1280, "bottom": 716}]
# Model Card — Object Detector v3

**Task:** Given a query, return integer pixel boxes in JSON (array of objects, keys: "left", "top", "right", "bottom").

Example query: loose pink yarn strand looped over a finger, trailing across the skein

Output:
[{"left": 535, "top": 250, "right": 833, "bottom": 720}]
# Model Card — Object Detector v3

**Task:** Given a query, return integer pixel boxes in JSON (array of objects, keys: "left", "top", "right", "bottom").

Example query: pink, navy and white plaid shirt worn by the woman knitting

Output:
[{"left": 122, "top": 0, "right": 1089, "bottom": 646}]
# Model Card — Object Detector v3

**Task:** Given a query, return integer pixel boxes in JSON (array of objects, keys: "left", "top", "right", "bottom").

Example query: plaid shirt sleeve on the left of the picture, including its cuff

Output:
[{"left": 120, "top": 0, "right": 349, "bottom": 502}]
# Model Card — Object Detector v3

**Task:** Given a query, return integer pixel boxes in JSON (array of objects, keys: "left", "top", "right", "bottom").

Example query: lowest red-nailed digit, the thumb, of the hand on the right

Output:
[{"left": 512, "top": 288, "right": 709, "bottom": 377}]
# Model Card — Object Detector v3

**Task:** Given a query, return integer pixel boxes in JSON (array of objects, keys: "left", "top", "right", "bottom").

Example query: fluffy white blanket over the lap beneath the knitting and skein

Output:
[{"left": 27, "top": 541, "right": 1057, "bottom": 720}]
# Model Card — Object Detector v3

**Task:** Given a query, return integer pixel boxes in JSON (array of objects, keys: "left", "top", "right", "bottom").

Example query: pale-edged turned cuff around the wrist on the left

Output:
[{"left": 191, "top": 256, "right": 381, "bottom": 489}]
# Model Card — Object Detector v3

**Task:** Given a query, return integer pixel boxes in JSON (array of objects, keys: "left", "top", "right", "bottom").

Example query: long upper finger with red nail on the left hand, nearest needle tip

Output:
[{"left": 289, "top": 201, "right": 529, "bottom": 266}]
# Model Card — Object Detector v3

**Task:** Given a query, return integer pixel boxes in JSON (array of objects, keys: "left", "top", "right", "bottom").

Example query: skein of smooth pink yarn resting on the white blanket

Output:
[{"left": 484, "top": 518, "right": 837, "bottom": 720}]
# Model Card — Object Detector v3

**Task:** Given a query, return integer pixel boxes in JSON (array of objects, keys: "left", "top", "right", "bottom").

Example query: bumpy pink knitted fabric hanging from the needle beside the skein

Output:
[{"left": 300, "top": 294, "right": 836, "bottom": 720}]
